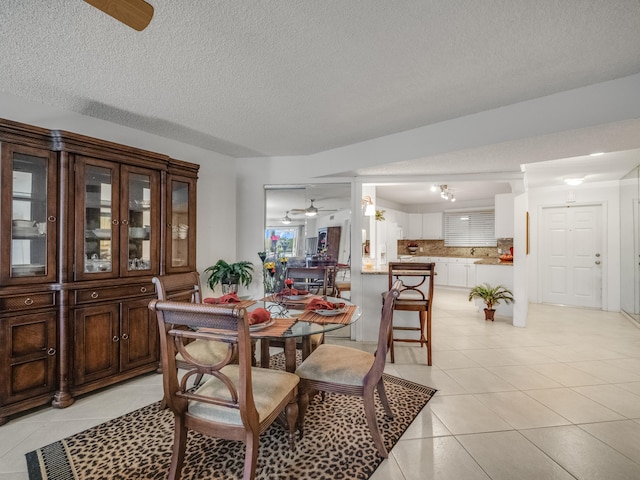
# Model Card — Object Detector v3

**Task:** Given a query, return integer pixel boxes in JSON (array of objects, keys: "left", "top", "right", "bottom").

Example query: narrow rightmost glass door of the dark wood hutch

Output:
[{"left": 166, "top": 175, "right": 196, "bottom": 273}]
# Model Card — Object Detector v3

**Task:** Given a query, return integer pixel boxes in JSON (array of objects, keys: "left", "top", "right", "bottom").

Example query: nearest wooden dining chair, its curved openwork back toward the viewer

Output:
[{"left": 149, "top": 300, "right": 299, "bottom": 480}]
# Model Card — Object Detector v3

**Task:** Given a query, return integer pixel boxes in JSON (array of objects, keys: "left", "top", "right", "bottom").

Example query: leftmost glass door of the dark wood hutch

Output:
[{"left": 0, "top": 144, "right": 57, "bottom": 284}]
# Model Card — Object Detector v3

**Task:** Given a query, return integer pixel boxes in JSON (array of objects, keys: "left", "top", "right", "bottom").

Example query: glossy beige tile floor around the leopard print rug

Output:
[{"left": 0, "top": 289, "right": 640, "bottom": 480}]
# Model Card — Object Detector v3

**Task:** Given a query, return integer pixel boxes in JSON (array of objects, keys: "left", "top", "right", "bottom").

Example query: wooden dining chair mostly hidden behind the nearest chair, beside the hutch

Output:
[{"left": 153, "top": 272, "right": 232, "bottom": 394}]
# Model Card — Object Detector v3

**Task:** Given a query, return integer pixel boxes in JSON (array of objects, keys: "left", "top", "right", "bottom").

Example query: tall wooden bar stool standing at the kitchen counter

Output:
[{"left": 382, "top": 262, "right": 436, "bottom": 366}]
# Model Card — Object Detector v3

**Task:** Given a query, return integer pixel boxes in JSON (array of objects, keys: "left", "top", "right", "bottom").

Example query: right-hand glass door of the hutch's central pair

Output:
[{"left": 120, "top": 166, "right": 160, "bottom": 276}]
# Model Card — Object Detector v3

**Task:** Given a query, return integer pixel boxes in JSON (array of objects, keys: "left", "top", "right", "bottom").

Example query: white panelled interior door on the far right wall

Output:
[{"left": 540, "top": 205, "right": 604, "bottom": 308}]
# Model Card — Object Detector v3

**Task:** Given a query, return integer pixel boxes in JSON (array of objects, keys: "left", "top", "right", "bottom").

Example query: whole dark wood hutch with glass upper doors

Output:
[{"left": 0, "top": 120, "right": 199, "bottom": 425}]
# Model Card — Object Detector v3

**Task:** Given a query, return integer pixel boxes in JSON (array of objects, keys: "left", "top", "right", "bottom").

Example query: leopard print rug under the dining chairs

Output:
[{"left": 27, "top": 354, "right": 435, "bottom": 480}]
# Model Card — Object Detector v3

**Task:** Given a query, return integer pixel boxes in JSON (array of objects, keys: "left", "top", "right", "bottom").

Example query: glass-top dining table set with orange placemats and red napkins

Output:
[{"left": 247, "top": 295, "right": 362, "bottom": 372}]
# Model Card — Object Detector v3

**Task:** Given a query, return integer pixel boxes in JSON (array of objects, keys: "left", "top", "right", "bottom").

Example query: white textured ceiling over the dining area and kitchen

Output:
[{"left": 0, "top": 0, "right": 640, "bottom": 203}]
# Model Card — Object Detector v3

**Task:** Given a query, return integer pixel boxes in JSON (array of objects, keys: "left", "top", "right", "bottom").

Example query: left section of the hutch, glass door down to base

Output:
[{"left": 0, "top": 123, "right": 59, "bottom": 425}]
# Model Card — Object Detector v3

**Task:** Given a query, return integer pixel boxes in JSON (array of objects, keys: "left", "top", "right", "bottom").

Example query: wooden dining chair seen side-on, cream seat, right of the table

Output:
[{"left": 296, "top": 281, "right": 401, "bottom": 458}]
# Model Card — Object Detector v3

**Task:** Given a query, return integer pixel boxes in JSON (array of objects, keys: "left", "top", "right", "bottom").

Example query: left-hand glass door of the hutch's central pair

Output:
[{"left": 75, "top": 157, "right": 120, "bottom": 280}]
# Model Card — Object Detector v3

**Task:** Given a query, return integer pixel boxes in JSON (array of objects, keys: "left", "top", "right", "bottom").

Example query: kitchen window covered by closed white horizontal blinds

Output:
[{"left": 444, "top": 209, "right": 498, "bottom": 247}]
